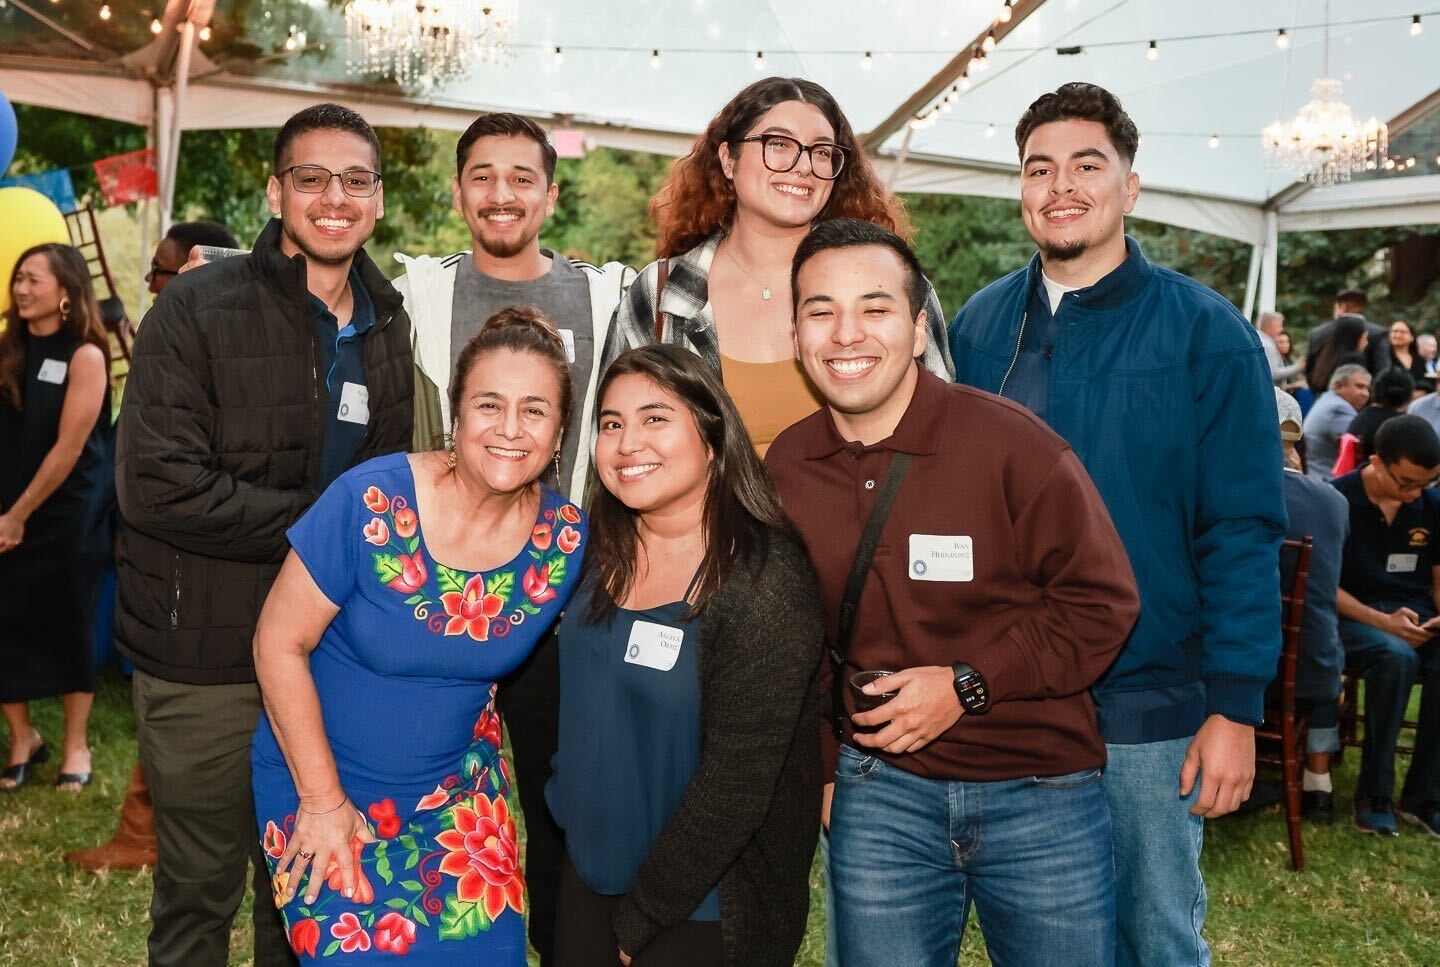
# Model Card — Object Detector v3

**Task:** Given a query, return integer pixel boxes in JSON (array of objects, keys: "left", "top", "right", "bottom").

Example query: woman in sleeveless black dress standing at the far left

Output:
[{"left": 0, "top": 245, "right": 109, "bottom": 791}]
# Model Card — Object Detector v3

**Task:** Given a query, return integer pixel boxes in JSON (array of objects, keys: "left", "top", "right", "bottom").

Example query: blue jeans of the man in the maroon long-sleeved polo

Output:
[{"left": 829, "top": 745, "right": 1115, "bottom": 967}]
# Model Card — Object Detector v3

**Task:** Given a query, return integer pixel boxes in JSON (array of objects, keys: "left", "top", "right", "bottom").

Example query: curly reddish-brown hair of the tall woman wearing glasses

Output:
[{"left": 649, "top": 78, "right": 910, "bottom": 259}]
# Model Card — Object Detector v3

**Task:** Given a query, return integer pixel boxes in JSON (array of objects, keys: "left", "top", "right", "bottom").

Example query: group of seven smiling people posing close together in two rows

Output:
[{"left": 0, "top": 78, "right": 1359, "bottom": 967}]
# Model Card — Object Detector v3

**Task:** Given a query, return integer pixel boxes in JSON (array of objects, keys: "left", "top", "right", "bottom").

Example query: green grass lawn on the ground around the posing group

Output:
[{"left": 0, "top": 673, "right": 1440, "bottom": 967}]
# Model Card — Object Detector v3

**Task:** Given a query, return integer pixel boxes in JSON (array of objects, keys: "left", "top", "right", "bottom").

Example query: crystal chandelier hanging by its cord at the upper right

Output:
[{"left": 1260, "top": 3, "right": 1390, "bottom": 189}]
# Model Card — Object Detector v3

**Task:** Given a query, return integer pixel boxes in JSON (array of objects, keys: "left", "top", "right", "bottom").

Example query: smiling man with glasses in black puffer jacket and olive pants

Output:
[{"left": 115, "top": 104, "right": 415, "bottom": 967}]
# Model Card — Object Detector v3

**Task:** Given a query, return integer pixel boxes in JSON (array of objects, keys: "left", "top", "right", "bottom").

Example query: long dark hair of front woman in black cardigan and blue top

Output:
[{"left": 585, "top": 345, "right": 791, "bottom": 625}]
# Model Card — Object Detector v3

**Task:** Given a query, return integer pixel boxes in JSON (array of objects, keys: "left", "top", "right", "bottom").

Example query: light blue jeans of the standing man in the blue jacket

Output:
[{"left": 1103, "top": 738, "right": 1210, "bottom": 967}]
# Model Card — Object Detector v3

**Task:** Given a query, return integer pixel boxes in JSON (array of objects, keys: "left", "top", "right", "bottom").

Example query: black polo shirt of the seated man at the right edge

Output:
[{"left": 1331, "top": 471, "right": 1440, "bottom": 620}]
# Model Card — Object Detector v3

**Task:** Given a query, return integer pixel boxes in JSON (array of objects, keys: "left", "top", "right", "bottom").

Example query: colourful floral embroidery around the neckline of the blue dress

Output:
[{"left": 360, "top": 485, "right": 580, "bottom": 642}]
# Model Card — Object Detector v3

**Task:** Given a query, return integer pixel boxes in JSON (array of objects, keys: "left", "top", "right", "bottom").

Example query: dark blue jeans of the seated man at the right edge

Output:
[{"left": 1341, "top": 615, "right": 1440, "bottom": 809}]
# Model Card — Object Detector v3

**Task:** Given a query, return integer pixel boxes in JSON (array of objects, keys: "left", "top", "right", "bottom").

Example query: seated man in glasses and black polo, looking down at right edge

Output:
[{"left": 1332, "top": 414, "right": 1440, "bottom": 836}]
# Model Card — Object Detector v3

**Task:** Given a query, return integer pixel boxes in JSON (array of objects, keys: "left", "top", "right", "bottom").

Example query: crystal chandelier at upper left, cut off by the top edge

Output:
[{"left": 346, "top": 0, "right": 517, "bottom": 91}]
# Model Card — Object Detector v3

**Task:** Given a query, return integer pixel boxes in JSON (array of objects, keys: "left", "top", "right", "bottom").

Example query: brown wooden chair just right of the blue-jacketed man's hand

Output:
[{"left": 1256, "top": 537, "right": 1315, "bottom": 872}]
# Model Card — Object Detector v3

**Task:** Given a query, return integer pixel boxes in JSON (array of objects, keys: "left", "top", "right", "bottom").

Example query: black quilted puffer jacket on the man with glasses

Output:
[{"left": 115, "top": 220, "right": 415, "bottom": 685}]
